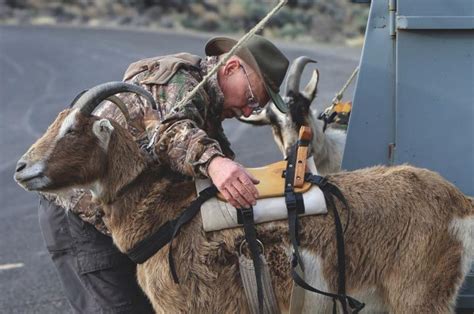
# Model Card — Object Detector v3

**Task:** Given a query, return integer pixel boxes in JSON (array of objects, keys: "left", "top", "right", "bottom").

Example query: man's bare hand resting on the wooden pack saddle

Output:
[{"left": 207, "top": 156, "right": 260, "bottom": 208}]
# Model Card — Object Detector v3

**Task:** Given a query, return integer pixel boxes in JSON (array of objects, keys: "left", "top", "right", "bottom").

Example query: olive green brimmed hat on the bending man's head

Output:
[{"left": 205, "top": 35, "right": 289, "bottom": 113}]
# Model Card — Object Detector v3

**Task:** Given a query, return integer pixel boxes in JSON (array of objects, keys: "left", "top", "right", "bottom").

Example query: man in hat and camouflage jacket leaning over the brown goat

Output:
[{"left": 40, "top": 36, "right": 288, "bottom": 313}]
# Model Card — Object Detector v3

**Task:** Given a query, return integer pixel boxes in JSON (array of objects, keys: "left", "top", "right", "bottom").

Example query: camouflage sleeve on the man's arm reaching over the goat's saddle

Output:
[{"left": 152, "top": 70, "right": 224, "bottom": 178}]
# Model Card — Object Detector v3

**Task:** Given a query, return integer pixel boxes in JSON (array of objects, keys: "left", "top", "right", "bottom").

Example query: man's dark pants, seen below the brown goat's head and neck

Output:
[{"left": 39, "top": 197, "right": 153, "bottom": 313}]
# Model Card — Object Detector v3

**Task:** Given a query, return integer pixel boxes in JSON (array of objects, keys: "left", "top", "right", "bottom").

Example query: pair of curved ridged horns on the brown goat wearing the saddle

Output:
[{"left": 74, "top": 82, "right": 157, "bottom": 120}]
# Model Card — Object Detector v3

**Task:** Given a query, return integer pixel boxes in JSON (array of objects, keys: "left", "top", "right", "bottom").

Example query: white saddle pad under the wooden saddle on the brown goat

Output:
[{"left": 196, "top": 158, "right": 327, "bottom": 231}]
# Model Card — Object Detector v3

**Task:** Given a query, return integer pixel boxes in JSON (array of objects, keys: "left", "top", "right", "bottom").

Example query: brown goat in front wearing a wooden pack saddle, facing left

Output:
[{"left": 15, "top": 83, "right": 474, "bottom": 314}]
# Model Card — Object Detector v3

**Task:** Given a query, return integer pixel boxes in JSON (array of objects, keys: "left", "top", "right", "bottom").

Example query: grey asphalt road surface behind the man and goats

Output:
[{"left": 0, "top": 26, "right": 360, "bottom": 313}]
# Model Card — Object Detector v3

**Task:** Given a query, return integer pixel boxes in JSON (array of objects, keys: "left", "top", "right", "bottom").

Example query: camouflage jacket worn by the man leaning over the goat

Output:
[{"left": 49, "top": 56, "right": 234, "bottom": 234}]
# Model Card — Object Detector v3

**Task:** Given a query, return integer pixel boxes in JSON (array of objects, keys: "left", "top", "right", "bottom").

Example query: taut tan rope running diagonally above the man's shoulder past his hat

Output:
[{"left": 177, "top": 0, "right": 287, "bottom": 108}]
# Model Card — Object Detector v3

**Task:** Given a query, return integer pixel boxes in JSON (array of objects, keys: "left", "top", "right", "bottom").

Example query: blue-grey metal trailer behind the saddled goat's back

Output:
[{"left": 342, "top": 0, "right": 474, "bottom": 313}]
